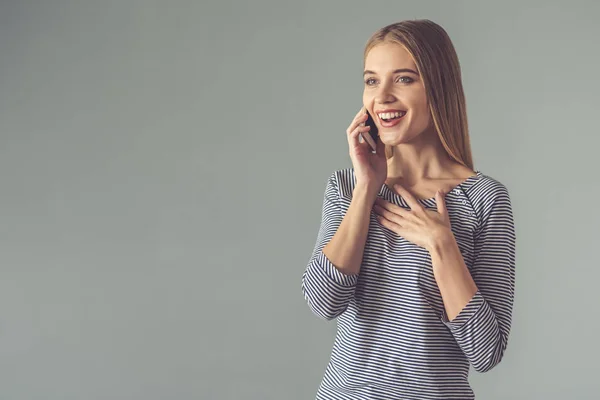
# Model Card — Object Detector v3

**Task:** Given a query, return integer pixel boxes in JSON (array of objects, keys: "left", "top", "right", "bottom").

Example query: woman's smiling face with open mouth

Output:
[{"left": 363, "top": 42, "right": 432, "bottom": 146}]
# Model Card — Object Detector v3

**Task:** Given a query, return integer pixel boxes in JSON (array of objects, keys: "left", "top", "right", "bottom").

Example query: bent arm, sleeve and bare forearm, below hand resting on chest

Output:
[{"left": 431, "top": 187, "right": 515, "bottom": 372}]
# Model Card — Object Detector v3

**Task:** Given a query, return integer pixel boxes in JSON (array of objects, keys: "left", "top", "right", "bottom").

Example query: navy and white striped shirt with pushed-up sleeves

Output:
[{"left": 302, "top": 168, "right": 515, "bottom": 400}]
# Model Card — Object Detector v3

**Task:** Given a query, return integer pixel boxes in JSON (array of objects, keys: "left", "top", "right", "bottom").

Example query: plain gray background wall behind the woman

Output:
[{"left": 0, "top": 0, "right": 600, "bottom": 400}]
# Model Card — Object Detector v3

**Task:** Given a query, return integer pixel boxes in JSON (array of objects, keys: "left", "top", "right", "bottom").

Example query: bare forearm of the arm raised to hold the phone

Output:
[{"left": 323, "top": 185, "right": 376, "bottom": 275}]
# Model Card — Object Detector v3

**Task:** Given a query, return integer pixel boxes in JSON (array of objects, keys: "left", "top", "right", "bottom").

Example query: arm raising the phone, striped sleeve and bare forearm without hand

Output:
[{"left": 302, "top": 170, "right": 376, "bottom": 320}]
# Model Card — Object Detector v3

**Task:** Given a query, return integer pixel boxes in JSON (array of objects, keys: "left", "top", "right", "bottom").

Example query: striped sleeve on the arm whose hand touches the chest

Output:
[{"left": 442, "top": 185, "right": 515, "bottom": 372}]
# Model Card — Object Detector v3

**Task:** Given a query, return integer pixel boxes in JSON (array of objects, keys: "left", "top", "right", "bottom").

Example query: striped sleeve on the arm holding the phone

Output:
[{"left": 302, "top": 173, "right": 358, "bottom": 320}]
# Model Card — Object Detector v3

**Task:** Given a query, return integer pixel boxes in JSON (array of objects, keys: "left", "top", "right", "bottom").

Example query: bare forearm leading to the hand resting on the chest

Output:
[{"left": 429, "top": 231, "right": 477, "bottom": 321}]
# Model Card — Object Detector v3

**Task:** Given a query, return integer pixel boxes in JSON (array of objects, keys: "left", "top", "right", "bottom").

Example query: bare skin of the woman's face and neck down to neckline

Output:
[{"left": 363, "top": 43, "right": 474, "bottom": 191}]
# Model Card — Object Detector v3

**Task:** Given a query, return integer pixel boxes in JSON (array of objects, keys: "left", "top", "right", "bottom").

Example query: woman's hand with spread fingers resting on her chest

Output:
[{"left": 373, "top": 184, "right": 452, "bottom": 250}]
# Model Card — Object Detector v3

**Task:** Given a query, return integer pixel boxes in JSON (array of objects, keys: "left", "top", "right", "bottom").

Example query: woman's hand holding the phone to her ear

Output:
[{"left": 346, "top": 107, "right": 387, "bottom": 193}]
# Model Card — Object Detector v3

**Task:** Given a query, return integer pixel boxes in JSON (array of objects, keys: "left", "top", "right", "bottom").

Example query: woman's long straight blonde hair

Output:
[{"left": 364, "top": 19, "right": 474, "bottom": 169}]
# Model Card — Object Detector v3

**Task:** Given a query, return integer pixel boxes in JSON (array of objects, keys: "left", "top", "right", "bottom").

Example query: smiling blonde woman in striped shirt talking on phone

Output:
[{"left": 302, "top": 20, "right": 515, "bottom": 400}]
